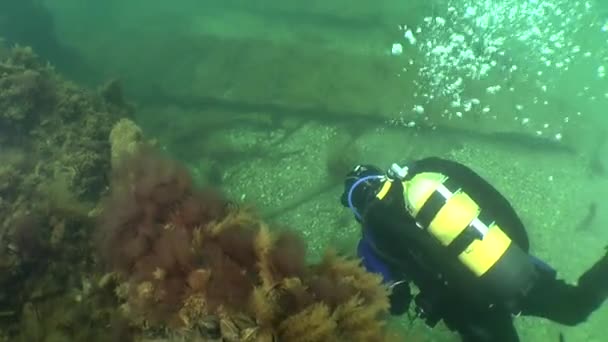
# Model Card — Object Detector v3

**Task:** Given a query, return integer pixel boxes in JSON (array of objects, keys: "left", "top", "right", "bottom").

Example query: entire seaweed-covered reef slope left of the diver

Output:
[{"left": 0, "top": 41, "right": 388, "bottom": 342}]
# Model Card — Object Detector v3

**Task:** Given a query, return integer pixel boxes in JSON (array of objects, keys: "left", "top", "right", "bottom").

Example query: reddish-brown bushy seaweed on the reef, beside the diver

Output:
[{"left": 98, "top": 148, "right": 388, "bottom": 341}]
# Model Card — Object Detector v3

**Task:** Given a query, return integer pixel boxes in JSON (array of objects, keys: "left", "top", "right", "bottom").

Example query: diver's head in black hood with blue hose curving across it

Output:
[{"left": 340, "top": 165, "right": 384, "bottom": 219}]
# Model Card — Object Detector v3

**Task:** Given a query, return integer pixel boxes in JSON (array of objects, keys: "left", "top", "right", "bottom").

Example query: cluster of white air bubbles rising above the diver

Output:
[{"left": 392, "top": 0, "right": 608, "bottom": 140}]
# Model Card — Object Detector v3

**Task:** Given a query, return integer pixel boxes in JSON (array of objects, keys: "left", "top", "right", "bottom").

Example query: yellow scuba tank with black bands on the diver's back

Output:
[{"left": 392, "top": 167, "right": 536, "bottom": 306}]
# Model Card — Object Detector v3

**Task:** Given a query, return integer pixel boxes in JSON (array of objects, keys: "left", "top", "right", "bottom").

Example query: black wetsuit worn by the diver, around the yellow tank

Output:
[{"left": 352, "top": 158, "right": 608, "bottom": 342}]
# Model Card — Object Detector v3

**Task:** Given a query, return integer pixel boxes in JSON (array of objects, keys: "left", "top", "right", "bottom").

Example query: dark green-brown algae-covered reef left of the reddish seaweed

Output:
[{"left": 0, "top": 40, "right": 132, "bottom": 341}]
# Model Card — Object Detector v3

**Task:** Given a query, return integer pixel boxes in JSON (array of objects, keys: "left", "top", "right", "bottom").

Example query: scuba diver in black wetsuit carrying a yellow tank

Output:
[{"left": 341, "top": 157, "right": 608, "bottom": 342}]
